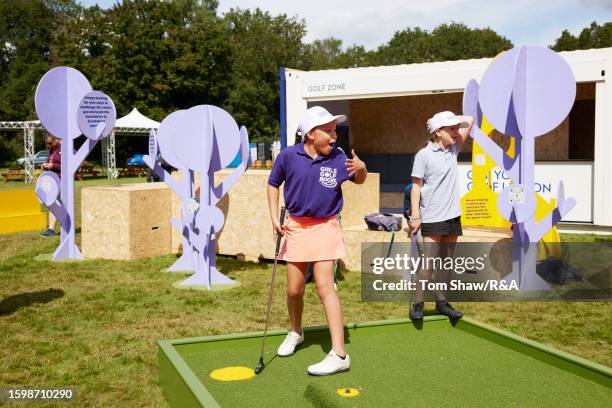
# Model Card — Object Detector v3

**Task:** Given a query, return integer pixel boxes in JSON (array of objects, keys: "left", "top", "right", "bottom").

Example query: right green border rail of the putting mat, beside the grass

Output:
[{"left": 455, "top": 317, "right": 612, "bottom": 389}]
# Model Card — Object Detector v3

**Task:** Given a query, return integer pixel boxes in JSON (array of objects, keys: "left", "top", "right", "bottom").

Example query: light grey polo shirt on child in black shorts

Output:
[{"left": 412, "top": 140, "right": 461, "bottom": 223}]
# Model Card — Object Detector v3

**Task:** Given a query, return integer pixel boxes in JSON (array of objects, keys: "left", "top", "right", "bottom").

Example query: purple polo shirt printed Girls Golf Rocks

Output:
[{"left": 268, "top": 143, "right": 354, "bottom": 218}]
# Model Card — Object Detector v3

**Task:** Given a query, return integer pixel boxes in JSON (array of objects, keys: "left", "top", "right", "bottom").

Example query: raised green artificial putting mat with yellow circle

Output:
[{"left": 159, "top": 317, "right": 612, "bottom": 408}]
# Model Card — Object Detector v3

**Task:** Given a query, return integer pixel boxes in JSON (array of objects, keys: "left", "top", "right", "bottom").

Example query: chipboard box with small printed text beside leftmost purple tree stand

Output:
[{"left": 81, "top": 183, "right": 172, "bottom": 260}]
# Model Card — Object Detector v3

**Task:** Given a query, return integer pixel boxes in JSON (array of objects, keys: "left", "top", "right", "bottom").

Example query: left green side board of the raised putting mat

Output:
[{"left": 157, "top": 340, "right": 220, "bottom": 408}]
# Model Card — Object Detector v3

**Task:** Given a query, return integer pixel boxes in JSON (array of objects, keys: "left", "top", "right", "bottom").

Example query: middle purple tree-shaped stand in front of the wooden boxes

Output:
[{"left": 145, "top": 105, "right": 250, "bottom": 289}]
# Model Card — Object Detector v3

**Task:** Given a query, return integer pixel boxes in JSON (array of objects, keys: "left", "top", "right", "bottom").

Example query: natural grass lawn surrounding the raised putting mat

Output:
[{"left": 0, "top": 178, "right": 612, "bottom": 407}]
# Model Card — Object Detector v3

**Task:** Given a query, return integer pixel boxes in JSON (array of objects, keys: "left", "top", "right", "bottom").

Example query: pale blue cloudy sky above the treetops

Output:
[{"left": 77, "top": 0, "right": 612, "bottom": 50}]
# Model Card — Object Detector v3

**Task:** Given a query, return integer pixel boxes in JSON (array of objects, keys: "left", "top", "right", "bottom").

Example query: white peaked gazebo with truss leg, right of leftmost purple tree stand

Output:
[{"left": 102, "top": 108, "right": 159, "bottom": 179}]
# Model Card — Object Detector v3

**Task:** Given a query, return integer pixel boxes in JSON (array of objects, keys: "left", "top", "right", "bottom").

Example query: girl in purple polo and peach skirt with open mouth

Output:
[{"left": 268, "top": 106, "right": 367, "bottom": 375}]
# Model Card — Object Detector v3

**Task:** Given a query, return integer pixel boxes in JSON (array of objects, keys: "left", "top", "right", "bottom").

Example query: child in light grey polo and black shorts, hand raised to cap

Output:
[{"left": 410, "top": 111, "right": 474, "bottom": 320}]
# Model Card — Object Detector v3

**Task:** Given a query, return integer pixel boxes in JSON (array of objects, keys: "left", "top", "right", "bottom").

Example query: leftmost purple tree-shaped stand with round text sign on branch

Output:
[{"left": 35, "top": 67, "right": 116, "bottom": 260}]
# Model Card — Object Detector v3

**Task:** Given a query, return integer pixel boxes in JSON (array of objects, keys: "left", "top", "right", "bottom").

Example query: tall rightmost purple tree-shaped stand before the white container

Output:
[{"left": 463, "top": 46, "right": 576, "bottom": 292}]
